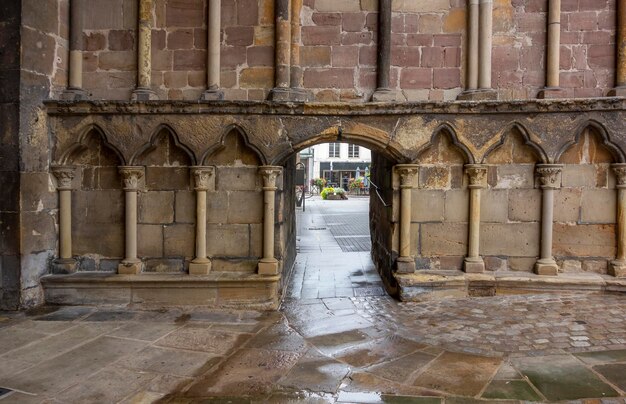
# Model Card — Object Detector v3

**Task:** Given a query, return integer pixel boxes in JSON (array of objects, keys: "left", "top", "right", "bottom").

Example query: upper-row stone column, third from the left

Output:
[{"left": 202, "top": 0, "right": 224, "bottom": 101}]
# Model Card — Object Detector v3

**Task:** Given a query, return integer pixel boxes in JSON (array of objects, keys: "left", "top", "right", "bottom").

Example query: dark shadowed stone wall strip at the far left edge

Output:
[{"left": 0, "top": 1, "right": 21, "bottom": 310}]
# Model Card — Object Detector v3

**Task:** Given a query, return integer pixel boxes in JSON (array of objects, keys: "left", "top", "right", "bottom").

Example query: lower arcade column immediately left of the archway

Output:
[{"left": 259, "top": 166, "right": 283, "bottom": 275}]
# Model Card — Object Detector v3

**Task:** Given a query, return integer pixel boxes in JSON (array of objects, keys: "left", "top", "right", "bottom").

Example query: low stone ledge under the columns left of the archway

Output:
[{"left": 41, "top": 272, "right": 280, "bottom": 310}]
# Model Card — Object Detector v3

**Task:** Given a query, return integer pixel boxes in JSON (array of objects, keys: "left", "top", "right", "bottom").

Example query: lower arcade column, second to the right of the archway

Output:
[{"left": 463, "top": 164, "right": 487, "bottom": 273}]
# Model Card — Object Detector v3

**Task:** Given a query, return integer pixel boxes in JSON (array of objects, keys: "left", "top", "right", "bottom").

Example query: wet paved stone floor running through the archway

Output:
[{"left": 0, "top": 200, "right": 626, "bottom": 404}]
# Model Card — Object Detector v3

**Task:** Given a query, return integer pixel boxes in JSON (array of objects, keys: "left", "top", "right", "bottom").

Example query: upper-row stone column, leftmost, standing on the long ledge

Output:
[{"left": 61, "top": 0, "right": 88, "bottom": 100}]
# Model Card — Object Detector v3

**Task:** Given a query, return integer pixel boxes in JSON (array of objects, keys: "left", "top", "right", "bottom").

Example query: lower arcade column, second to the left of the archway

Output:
[{"left": 189, "top": 166, "right": 215, "bottom": 275}]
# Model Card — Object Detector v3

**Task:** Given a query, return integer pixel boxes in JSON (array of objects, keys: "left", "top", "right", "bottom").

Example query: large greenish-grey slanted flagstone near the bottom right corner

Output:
[{"left": 511, "top": 355, "right": 619, "bottom": 401}]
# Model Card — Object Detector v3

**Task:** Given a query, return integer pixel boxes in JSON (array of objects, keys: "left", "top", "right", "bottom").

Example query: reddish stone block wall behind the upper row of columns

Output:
[{"left": 74, "top": 0, "right": 616, "bottom": 102}]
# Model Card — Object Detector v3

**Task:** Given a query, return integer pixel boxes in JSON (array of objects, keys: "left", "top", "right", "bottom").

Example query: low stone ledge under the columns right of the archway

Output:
[{"left": 394, "top": 271, "right": 626, "bottom": 301}]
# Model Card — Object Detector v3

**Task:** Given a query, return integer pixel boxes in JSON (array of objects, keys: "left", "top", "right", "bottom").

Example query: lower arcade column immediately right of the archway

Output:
[{"left": 395, "top": 164, "right": 418, "bottom": 274}]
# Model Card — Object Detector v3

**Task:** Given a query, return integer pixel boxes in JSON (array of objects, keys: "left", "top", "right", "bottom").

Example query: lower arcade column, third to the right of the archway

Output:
[{"left": 535, "top": 164, "right": 563, "bottom": 276}]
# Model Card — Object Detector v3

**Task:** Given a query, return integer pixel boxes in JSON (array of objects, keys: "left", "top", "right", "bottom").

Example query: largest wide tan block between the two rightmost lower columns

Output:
[{"left": 553, "top": 223, "right": 615, "bottom": 257}]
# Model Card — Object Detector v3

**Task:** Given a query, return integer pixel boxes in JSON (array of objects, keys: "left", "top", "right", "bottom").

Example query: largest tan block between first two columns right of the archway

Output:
[{"left": 420, "top": 223, "right": 467, "bottom": 257}]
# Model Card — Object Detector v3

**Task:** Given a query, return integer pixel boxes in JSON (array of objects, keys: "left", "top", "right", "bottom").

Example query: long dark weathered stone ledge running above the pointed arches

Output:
[{"left": 44, "top": 97, "right": 626, "bottom": 116}]
